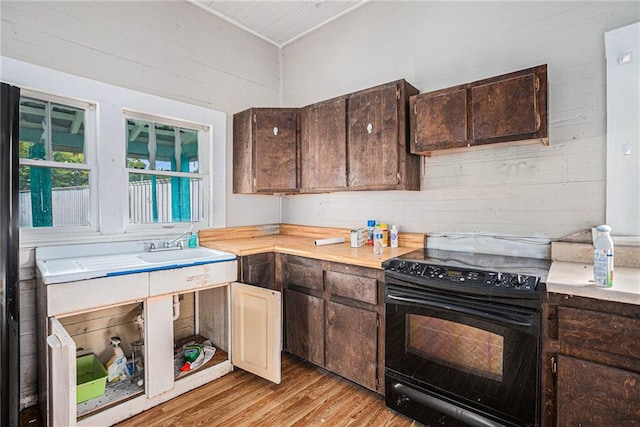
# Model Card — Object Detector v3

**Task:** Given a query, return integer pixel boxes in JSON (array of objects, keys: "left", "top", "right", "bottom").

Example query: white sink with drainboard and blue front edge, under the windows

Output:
[{"left": 36, "top": 242, "right": 236, "bottom": 284}]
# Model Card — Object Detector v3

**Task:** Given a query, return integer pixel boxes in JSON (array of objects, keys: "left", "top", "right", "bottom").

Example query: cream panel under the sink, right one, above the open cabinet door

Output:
[{"left": 149, "top": 261, "right": 238, "bottom": 296}]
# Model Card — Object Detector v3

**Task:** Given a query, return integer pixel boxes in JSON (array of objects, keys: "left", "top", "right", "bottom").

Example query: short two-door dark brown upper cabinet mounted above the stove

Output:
[{"left": 409, "top": 65, "right": 549, "bottom": 155}]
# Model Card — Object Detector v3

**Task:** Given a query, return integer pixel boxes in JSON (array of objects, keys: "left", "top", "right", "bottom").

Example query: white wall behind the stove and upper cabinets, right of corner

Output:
[{"left": 283, "top": 1, "right": 640, "bottom": 238}]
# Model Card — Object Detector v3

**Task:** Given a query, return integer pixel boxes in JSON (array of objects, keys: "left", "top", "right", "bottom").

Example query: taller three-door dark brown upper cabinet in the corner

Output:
[{"left": 233, "top": 80, "right": 420, "bottom": 194}]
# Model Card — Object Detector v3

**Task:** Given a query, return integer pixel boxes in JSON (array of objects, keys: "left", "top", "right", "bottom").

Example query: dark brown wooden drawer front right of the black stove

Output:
[{"left": 558, "top": 307, "right": 640, "bottom": 360}]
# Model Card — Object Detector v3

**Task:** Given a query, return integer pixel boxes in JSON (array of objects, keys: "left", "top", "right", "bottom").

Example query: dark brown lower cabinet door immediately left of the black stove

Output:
[{"left": 325, "top": 301, "right": 378, "bottom": 391}]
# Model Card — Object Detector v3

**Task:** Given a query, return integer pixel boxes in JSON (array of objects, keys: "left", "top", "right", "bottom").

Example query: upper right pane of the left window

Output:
[{"left": 51, "top": 104, "right": 84, "bottom": 163}]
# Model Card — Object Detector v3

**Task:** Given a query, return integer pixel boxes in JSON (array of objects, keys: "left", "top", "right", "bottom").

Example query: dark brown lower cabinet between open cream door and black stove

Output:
[{"left": 276, "top": 254, "right": 384, "bottom": 393}]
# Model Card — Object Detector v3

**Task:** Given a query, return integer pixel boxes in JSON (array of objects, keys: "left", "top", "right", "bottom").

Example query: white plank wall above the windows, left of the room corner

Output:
[{"left": 0, "top": 0, "right": 280, "bottom": 226}]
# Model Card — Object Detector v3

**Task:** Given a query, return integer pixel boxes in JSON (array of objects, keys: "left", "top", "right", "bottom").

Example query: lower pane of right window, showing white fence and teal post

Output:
[{"left": 129, "top": 173, "right": 204, "bottom": 224}]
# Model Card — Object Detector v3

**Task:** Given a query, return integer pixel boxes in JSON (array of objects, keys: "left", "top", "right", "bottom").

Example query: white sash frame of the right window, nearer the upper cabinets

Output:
[{"left": 122, "top": 108, "right": 213, "bottom": 232}]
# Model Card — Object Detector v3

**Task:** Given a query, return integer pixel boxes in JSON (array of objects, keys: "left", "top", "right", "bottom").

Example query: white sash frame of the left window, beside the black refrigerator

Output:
[{"left": 19, "top": 88, "right": 99, "bottom": 241}]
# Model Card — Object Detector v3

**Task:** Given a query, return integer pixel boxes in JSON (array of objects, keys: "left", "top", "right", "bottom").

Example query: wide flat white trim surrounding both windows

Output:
[{"left": 0, "top": 55, "right": 225, "bottom": 248}]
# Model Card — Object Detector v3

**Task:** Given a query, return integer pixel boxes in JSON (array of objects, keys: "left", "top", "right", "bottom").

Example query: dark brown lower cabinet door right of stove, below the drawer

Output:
[{"left": 557, "top": 355, "right": 640, "bottom": 426}]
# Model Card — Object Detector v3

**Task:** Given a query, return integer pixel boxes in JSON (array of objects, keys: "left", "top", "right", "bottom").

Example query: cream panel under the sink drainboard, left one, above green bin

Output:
[{"left": 47, "top": 273, "right": 149, "bottom": 316}]
